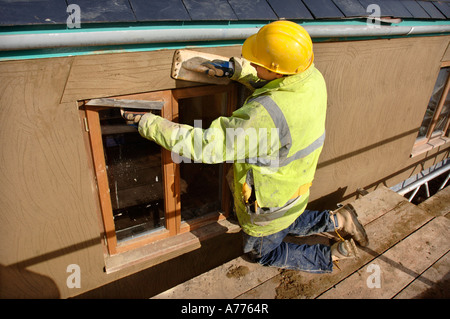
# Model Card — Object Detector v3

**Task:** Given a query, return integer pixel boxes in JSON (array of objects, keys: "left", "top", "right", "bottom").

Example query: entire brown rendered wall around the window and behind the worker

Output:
[{"left": 0, "top": 36, "right": 450, "bottom": 298}]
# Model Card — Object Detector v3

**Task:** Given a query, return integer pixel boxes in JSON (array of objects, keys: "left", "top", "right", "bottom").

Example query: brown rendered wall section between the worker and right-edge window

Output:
[{"left": 311, "top": 37, "right": 449, "bottom": 205}]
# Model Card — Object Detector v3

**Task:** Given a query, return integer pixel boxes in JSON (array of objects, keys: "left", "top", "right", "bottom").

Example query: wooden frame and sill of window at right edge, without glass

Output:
[{"left": 411, "top": 61, "right": 450, "bottom": 157}]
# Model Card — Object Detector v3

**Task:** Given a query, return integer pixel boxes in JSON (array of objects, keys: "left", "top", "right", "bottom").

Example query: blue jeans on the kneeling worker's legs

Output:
[{"left": 244, "top": 210, "right": 337, "bottom": 273}]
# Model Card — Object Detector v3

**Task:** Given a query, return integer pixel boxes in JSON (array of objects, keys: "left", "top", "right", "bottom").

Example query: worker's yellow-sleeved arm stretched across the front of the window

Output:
[{"left": 139, "top": 103, "right": 279, "bottom": 164}]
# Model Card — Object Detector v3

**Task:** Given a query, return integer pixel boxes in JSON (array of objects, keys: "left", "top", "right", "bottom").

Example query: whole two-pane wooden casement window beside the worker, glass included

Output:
[{"left": 81, "top": 84, "right": 237, "bottom": 255}]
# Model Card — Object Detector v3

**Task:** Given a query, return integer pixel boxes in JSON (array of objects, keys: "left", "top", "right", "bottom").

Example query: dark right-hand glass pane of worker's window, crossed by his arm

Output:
[{"left": 178, "top": 93, "right": 227, "bottom": 220}]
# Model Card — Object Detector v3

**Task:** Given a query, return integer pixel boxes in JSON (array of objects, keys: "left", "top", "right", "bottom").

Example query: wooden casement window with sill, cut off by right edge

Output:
[{"left": 411, "top": 62, "right": 450, "bottom": 156}]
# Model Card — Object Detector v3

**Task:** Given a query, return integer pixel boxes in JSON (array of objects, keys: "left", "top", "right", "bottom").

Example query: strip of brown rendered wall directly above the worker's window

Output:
[{"left": 62, "top": 46, "right": 241, "bottom": 102}]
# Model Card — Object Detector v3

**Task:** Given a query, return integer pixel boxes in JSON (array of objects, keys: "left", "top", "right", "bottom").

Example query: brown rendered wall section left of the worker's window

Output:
[{"left": 0, "top": 58, "right": 108, "bottom": 298}]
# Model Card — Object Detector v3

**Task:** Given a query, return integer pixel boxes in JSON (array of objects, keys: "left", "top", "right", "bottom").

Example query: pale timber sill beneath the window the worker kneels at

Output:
[{"left": 105, "top": 220, "right": 240, "bottom": 274}]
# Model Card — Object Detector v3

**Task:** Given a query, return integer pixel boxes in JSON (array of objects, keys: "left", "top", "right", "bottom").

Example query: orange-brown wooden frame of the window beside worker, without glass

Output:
[{"left": 84, "top": 83, "right": 237, "bottom": 256}]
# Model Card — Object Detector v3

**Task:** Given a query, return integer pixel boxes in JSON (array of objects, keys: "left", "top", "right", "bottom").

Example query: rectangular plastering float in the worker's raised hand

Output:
[{"left": 172, "top": 50, "right": 230, "bottom": 85}]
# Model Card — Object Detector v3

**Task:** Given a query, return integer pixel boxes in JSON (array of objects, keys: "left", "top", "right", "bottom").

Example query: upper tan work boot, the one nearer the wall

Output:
[{"left": 330, "top": 204, "right": 369, "bottom": 247}]
